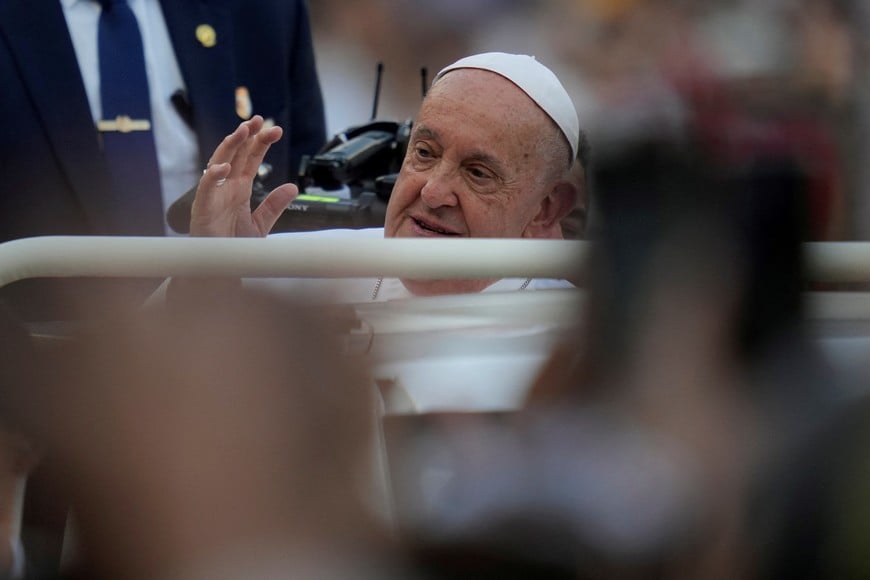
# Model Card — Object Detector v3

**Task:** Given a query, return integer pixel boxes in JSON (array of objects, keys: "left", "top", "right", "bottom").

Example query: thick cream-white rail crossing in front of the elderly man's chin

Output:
[{"left": 0, "top": 236, "right": 588, "bottom": 286}]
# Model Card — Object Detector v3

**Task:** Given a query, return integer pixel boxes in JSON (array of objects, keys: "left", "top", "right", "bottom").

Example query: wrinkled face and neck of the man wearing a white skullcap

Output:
[{"left": 384, "top": 69, "right": 558, "bottom": 294}]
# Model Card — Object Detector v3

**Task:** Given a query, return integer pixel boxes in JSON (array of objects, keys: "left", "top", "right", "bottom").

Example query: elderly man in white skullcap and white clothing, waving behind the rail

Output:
[{"left": 190, "top": 53, "right": 580, "bottom": 300}]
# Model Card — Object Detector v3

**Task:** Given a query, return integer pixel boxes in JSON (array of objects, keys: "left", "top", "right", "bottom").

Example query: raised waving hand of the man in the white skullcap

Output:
[{"left": 190, "top": 115, "right": 299, "bottom": 237}]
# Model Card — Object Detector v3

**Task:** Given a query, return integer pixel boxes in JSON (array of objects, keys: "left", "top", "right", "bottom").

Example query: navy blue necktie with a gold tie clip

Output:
[{"left": 97, "top": 0, "right": 164, "bottom": 236}]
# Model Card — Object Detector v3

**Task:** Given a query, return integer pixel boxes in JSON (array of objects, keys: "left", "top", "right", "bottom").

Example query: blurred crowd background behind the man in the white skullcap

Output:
[{"left": 311, "top": 0, "right": 870, "bottom": 240}]
